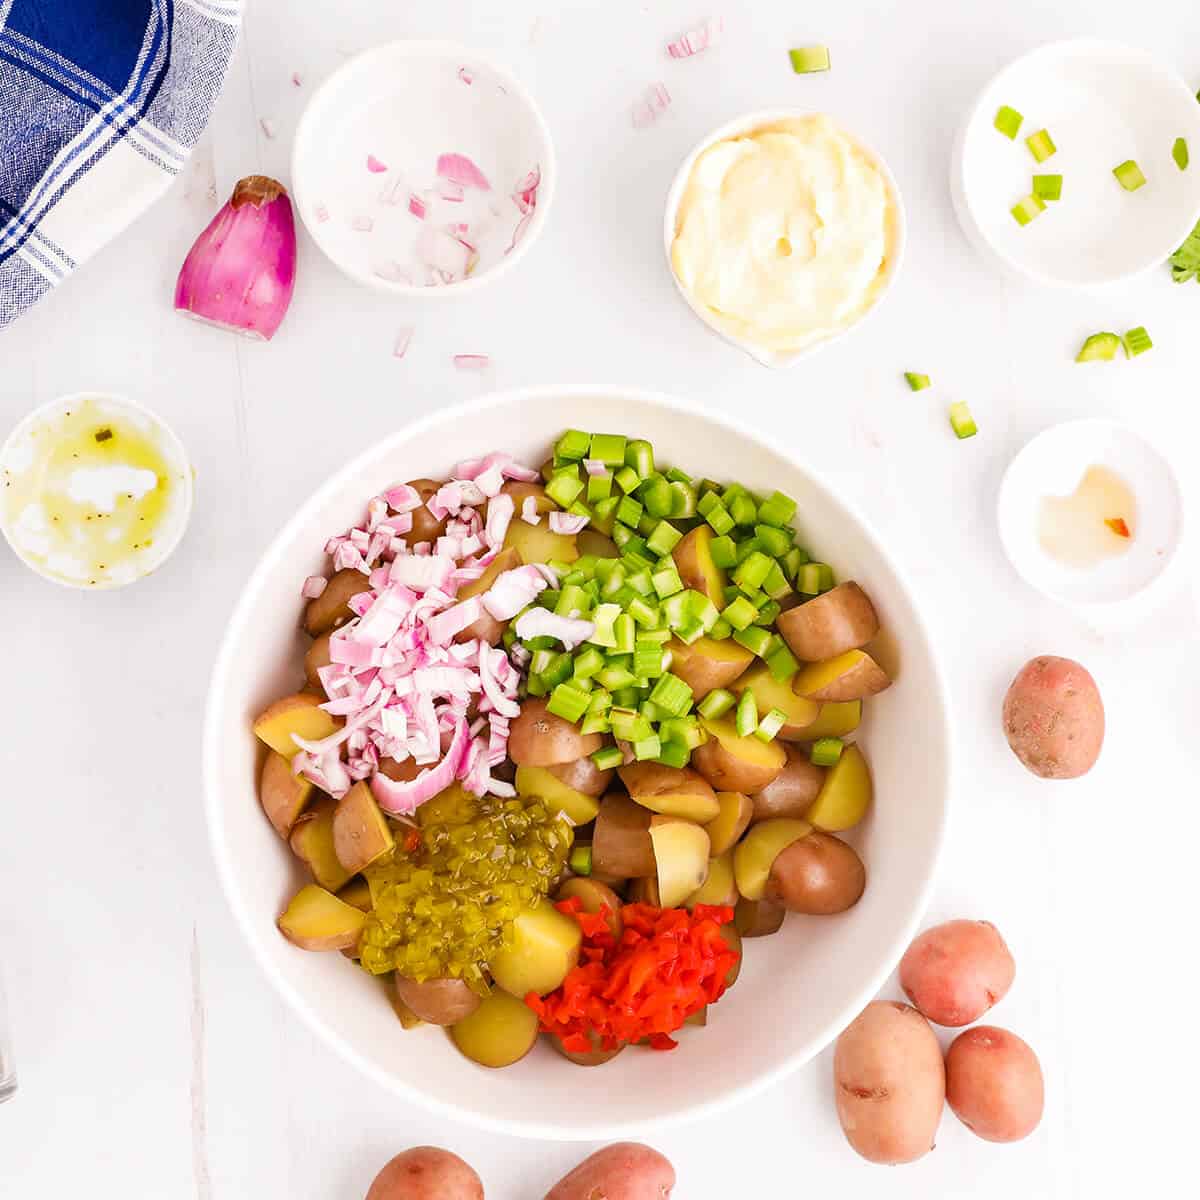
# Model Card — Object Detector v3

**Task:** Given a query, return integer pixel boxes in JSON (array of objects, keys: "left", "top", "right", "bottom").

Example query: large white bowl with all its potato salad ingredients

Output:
[{"left": 203, "top": 386, "right": 953, "bottom": 1140}]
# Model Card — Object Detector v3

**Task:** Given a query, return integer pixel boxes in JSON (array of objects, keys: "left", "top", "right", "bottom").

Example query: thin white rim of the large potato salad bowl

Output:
[{"left": 202, "top": 384, "right": 956, "bottom": 1141}]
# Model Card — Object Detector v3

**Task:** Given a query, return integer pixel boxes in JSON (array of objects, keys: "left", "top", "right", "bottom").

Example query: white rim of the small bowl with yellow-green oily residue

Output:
[{"left": 0, "top": 391, "right": 194, "bottom": 592}]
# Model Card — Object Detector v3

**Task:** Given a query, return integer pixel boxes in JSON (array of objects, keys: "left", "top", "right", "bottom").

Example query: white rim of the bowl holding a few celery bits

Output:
[{"left": 950, "top": 37, "right": 1200, "bottom": 292}]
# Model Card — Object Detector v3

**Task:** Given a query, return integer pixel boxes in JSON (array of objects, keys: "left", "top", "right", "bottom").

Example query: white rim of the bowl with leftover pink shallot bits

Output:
[{"left": 290, "top": 37, "right": 558, "bottom": 299}]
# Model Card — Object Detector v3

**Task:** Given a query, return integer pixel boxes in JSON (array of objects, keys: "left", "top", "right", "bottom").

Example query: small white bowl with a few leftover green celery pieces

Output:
[{"left": 950, "top": 38, "right": 1200, "bottom": 288}]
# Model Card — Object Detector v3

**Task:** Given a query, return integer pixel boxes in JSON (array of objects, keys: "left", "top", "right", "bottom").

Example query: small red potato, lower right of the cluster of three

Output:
[{"left": 946, "top": 1025, "right": 1045, "bottom": 1141}]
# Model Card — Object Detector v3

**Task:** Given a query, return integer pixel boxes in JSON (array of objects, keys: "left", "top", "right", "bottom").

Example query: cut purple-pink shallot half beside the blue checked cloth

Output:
[{"left": 175, "top": 175, "right": 296, "bottom": 341}]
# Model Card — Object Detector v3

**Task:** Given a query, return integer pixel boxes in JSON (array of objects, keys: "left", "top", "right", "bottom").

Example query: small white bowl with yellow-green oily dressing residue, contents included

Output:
[{"left": 0, "top": 392, "right": 193, "bottom": 592}]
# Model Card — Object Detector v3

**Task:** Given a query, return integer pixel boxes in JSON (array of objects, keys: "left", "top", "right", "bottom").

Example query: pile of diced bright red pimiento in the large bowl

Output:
[{"left": 526, "top": 896, "right": 738, "bottom": 1054}]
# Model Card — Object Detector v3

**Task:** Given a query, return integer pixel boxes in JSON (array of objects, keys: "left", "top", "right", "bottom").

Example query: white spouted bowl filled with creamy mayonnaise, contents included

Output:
[{"left": 662, "top": 108, "right": 905, "bottom": 367}]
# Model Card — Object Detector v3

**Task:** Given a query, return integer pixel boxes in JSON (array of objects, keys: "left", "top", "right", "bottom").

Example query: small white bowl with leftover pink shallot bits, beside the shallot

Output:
[{"left": 292, "top": 41, "right": 557, "bottom": 296}]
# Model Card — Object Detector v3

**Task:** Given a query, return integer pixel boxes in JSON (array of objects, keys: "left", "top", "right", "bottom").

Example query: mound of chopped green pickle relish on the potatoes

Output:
[{"left": 361, "top": 788, "right": 572, "bottom": 995}]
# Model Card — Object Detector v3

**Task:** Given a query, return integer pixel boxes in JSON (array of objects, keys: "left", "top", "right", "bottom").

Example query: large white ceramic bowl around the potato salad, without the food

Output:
[{"left": 204, "top": 386, "right": 952, "bottom": 1141}]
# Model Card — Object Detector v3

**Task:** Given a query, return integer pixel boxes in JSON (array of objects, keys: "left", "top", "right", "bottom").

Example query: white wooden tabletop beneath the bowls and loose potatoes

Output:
[{"left": 0, "top": 0, "right": 1200, "bottom": 1200}]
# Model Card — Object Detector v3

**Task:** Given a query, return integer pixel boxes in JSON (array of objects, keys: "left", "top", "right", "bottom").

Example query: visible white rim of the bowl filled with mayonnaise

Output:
[{"left": 662, "top": 108, "right": 907, "bottom": 367}]
